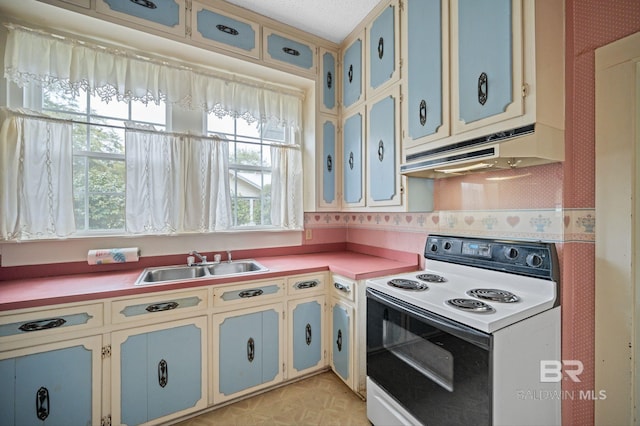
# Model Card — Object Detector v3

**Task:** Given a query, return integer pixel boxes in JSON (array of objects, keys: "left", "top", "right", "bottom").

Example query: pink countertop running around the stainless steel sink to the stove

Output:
[{"left": 0, "top": 251, "right": 418, "bottom": 311}]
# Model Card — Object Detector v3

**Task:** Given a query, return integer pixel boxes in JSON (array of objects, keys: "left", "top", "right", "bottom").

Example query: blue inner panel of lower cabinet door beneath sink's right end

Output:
[{"left": 218, "top": 310, "right": 279, "bottom": 395}]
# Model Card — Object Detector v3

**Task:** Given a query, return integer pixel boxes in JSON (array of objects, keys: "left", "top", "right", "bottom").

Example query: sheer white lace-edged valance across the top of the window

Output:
[{"left": 4, "top": 25, "right": 303, "bottom": 128}]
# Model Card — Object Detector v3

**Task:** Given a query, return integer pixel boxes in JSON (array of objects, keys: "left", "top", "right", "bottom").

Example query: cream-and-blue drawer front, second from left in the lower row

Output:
[{"left": 111, "top": 289, "right": 207, "bottom": 323}]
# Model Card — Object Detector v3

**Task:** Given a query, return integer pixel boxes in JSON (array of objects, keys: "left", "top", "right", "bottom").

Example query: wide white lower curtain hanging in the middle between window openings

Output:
[{"left": 126, "top": 126, "right": 231, "bottom": 234}]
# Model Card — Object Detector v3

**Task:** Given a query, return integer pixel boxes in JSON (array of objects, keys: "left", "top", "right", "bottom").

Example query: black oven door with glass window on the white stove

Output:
[{"left": 367, "top": 288, "right": 492, "bottom": 425}]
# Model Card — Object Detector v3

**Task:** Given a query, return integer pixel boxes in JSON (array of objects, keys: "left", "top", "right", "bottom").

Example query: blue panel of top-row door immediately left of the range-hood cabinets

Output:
[{"left": 369, "top": 6, "right": 397, "bottom": 89}]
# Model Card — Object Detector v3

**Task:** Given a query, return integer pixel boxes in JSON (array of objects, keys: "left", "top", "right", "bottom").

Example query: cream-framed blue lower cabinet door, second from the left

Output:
[{"left": 111, "top": 316, "right": 207, "bottom": 425}]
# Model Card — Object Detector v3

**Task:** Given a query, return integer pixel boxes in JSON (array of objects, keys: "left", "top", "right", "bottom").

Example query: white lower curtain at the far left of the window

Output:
[{"left": 0, "top": 108, "right": 75, "bottom": 240}]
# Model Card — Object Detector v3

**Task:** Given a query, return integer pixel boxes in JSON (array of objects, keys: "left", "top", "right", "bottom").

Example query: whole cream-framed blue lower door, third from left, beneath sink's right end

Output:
[{"left": 213, "top": 303, "right": 283, "bottom": 404}]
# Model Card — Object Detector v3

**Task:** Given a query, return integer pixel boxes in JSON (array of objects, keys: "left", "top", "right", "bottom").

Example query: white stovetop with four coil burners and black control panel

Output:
[{"left": 367, "top": 235, "right": 559, "bottom": 333}]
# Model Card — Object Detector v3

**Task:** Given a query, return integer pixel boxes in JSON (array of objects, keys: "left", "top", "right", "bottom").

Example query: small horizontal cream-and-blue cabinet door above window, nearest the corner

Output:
[{"left": 263, "top": 28, "right": 316, "bottom": 74}]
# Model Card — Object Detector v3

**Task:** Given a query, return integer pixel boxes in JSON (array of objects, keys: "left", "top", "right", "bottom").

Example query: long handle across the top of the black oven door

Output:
[{"left": 367, "top": 288, "right": 491, "bottom": 350}]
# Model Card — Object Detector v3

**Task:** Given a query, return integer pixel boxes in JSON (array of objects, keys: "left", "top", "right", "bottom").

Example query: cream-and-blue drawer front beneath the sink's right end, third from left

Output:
[{"left": 213, "top": 279, "right": 284, "bottom": 307}]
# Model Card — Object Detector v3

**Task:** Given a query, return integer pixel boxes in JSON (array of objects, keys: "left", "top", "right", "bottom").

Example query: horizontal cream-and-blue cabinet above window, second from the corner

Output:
[{"left": 191, "top": 0, "right": 260, "bottom": 59}]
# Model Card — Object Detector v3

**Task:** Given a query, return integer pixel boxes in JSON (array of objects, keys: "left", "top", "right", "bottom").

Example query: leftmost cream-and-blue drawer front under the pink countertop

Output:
[{"left": 0, "top": 303, "right": 103, "bottom": 342}]
